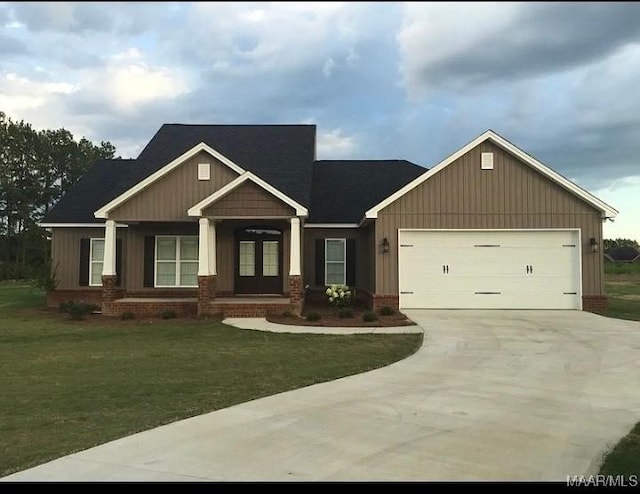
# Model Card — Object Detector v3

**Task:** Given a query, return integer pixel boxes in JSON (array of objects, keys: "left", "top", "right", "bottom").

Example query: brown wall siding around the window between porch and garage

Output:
[{"left": 303, "top": 226, "right": 374, "bottom": 292}]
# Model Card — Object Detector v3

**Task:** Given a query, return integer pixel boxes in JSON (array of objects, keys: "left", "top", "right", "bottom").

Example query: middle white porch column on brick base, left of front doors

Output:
[{"left": 198, "top": 218, "right": 216, "bottom": 317}]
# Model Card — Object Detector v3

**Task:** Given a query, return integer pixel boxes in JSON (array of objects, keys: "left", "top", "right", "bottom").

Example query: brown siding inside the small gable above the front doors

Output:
[{"left": 202, "top": 181, "right": 296, "bottom": 217}]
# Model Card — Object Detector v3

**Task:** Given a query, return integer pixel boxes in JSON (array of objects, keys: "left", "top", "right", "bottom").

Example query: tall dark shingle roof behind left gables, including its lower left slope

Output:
[{"left": 42, "top": 124, "right": 316, "bottom": 223}]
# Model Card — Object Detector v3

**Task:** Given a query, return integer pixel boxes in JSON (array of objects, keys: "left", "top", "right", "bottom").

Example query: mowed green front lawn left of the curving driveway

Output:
[{"left": 0, "top": 283, "right": 422, "bottom": 476}]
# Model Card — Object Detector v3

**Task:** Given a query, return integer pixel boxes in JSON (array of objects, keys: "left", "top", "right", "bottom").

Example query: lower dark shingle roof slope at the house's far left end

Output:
[{"left": 42, "top": 159, "right": 136, "bottom": 223}]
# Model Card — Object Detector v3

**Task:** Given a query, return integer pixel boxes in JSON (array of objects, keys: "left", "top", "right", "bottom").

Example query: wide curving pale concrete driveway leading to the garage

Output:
[{"left": 3, "top": 310, "right": 640, "bottom": 481}]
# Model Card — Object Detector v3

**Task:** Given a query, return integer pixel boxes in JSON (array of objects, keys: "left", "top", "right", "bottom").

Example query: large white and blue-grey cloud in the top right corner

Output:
[{"left": 397, "top": 2, "right": 640, "bottom": 98}]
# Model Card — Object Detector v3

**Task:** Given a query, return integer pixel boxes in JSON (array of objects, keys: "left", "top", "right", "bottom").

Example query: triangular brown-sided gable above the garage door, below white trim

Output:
[{"left": 380, "top": 140, "right": 599, "bottom": 216}]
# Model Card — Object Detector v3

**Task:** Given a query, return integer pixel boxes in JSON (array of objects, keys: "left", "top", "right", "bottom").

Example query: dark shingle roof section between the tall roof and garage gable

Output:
[{"left": 309, "top": 160, "right": 427, "bottom": 223}]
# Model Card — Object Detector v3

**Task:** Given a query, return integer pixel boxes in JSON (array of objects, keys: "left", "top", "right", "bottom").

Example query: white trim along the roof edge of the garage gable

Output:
[{"left": 365, "top": 130, "right": 618, "bottom": 218}]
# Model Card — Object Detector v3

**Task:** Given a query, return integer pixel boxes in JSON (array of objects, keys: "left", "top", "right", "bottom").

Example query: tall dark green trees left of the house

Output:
[{"left": 0, "top": 111, "right": 116, "bottom": 279}]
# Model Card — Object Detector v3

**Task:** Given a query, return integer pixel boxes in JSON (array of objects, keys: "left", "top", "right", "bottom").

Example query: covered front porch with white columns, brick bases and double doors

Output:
[{"left": 102, "top": 217, "right": 304, "bottom": 317}]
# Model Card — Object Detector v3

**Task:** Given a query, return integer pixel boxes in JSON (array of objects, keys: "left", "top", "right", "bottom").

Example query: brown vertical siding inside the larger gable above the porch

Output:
[{"left": 109, "top": 151, "right": 238, "bottom": 221}]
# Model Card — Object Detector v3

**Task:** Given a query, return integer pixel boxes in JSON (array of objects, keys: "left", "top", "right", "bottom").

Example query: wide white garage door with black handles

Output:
[{"left": 398, "top": 230, "right": 581, "bottom": 309}]
